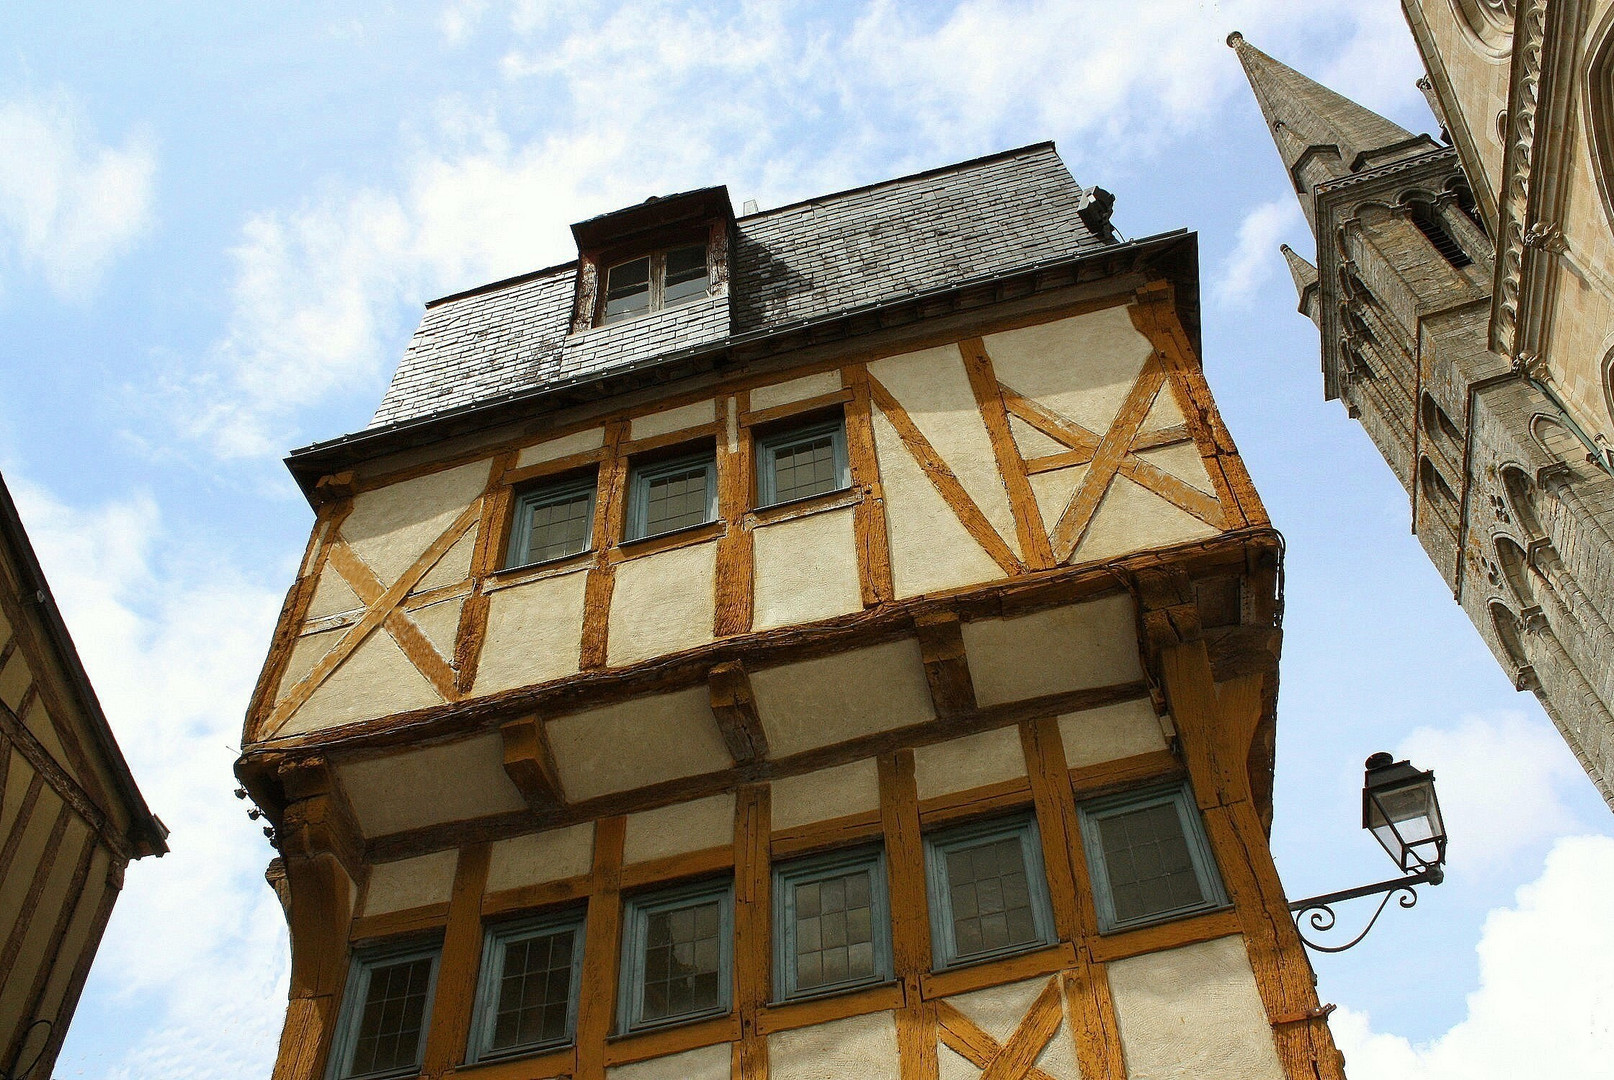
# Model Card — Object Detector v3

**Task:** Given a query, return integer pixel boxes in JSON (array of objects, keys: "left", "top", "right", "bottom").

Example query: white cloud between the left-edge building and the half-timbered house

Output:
[{"left": 8, "top": 476, "right": 291, "bottom": 1078}]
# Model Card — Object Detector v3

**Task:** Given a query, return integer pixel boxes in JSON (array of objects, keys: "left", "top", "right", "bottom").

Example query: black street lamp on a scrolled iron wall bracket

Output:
[{"left": 1290, "top": 754, "right": 1446, "bottom": 952}]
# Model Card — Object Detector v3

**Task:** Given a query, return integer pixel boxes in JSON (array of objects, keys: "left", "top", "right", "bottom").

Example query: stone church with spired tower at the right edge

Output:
[{"left": 1228, "top": 16, "right": 1614, "bottom": 804}]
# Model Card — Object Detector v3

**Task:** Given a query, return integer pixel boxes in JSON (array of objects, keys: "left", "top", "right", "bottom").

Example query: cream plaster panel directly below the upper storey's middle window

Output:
[{"left": 605, "top": 541, "right": 717, "bottom": 667}]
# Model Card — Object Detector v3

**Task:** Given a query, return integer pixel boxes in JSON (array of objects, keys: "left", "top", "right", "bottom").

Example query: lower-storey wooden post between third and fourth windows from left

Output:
[{"left": 733, "top": 785, "right": 773, "bottom": 1080}]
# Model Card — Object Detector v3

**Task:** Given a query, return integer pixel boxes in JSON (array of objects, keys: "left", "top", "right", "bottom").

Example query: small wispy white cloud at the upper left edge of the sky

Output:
[{"left": 0, "top": 92, "right": 157, "bottom": 299}]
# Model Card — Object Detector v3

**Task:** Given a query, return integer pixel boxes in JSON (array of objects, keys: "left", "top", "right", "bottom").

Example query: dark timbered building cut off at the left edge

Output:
[{"left": 0, "top": 481, "right": 168, "bottom": 1080}]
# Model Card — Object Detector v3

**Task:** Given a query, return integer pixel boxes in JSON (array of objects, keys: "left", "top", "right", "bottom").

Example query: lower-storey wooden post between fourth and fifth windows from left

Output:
[{"left": 878, "top": 751, "right": 939, "bottom": 1080}]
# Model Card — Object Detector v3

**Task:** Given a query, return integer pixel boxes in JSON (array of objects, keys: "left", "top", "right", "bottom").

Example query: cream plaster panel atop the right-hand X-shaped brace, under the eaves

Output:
[{"left": 985, "top": 303, "right": 1154, "bottom": 434}]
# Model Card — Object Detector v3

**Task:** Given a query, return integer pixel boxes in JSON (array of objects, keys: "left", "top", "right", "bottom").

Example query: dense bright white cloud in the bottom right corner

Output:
[{"left": 1333, "top": 833, "right": 1614, "bottom": 1080}]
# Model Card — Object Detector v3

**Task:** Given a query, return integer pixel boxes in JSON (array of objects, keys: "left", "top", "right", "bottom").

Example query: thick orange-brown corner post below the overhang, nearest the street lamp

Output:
[{"left": 1160, "top": 639, "right": 1344, "bottom": 1080}]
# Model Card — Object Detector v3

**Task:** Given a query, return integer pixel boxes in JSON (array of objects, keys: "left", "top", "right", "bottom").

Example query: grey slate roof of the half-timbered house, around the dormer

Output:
[{"left": 370, "top": 142, "right": 1112, "bottom": 428}]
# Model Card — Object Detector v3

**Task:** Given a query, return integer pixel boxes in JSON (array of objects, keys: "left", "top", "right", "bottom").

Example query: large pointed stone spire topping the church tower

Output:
[{"left": 1227, "top": 31, "right": 1436, "bottom": 232}]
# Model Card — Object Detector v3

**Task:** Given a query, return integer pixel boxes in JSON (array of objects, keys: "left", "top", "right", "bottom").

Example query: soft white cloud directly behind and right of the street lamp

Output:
[{"left": 1396, "top": 712, "right": 1585, "bottom": 875}]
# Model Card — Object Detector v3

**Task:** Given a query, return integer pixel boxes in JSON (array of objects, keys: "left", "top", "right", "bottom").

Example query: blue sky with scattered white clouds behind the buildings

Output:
[{"left": 0, "top": 0, "right": 1614, "bottom": 1080}]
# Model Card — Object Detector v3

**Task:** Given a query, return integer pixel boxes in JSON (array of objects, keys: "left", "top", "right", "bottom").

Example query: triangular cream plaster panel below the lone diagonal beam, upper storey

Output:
[{"left": 873, "top": 408, "right": 1004, "bottom": 597}]
